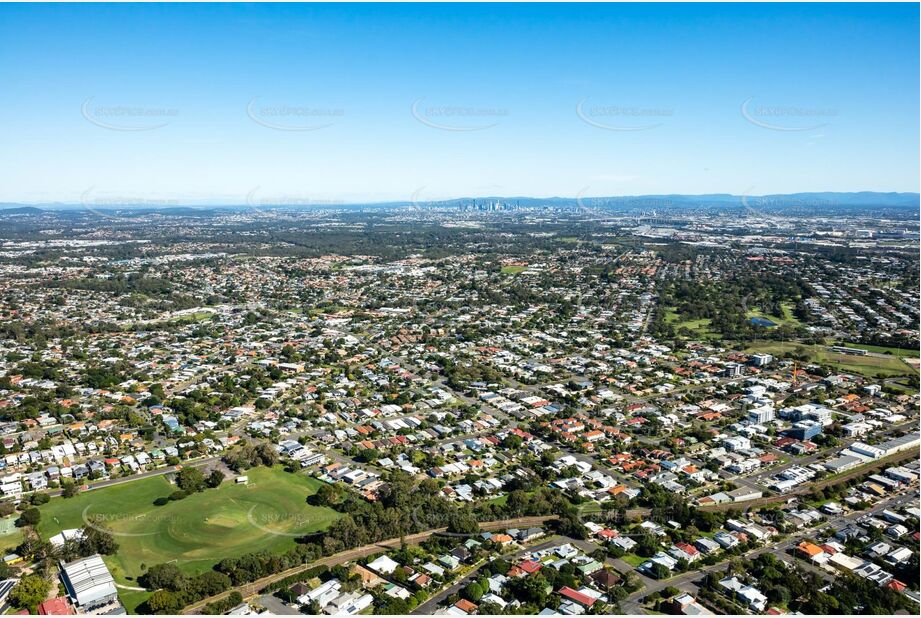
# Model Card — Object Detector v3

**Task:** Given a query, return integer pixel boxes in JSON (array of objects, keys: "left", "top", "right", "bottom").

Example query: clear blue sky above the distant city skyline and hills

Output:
[{"left": 0, "top": 4, "right": 919, "bottom": 203}]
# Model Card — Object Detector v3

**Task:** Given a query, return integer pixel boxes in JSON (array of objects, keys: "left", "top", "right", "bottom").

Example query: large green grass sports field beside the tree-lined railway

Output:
[{"left": 38, "top": 467, "right": 340, "bottom": 609}]
